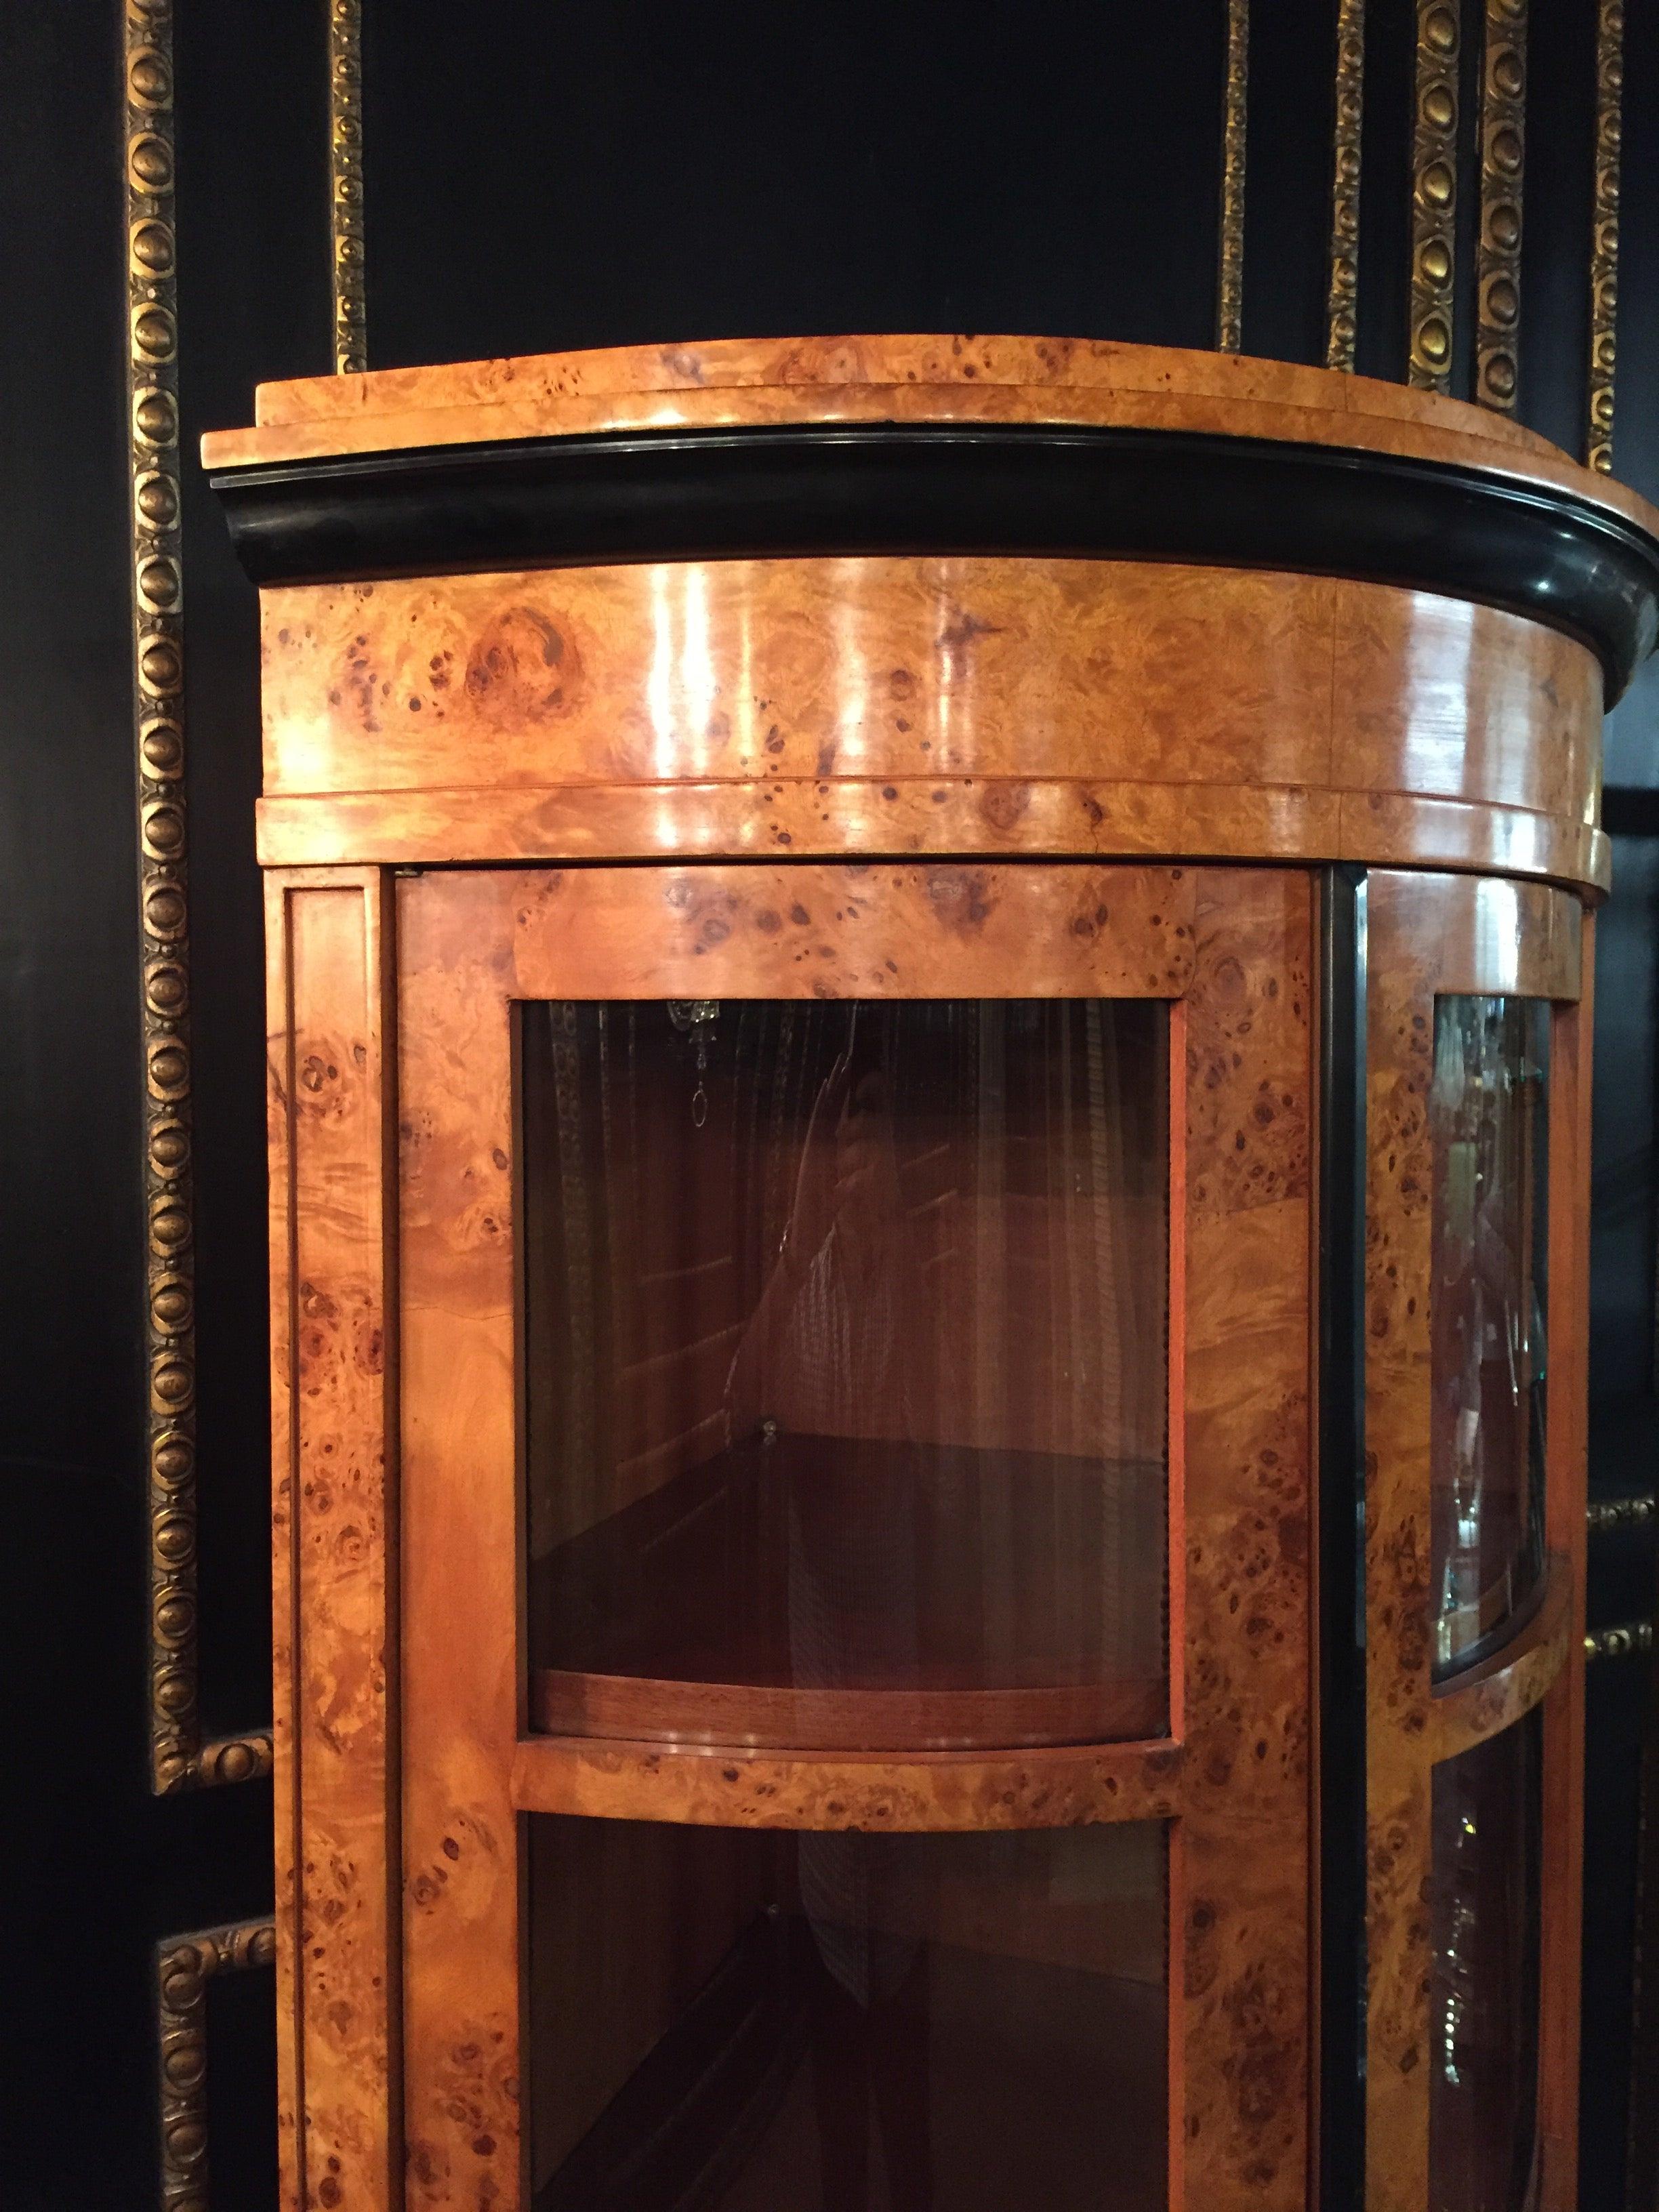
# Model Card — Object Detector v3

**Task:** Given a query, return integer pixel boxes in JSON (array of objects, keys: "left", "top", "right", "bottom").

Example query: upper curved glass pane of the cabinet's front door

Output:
[{"left": 520, "top": 1000, "right": 1168, "bottom": 1750}]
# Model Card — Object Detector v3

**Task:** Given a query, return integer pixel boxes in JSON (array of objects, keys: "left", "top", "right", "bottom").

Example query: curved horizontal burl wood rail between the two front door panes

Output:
[{"left": 513, "top": 1736, "right": 1183, "bottom": 1834}]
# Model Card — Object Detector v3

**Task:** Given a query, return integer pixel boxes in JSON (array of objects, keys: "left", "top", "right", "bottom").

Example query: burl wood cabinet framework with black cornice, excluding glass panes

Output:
[{"left": 206, "top": 336, "right": 1659, "bottom": 2212}]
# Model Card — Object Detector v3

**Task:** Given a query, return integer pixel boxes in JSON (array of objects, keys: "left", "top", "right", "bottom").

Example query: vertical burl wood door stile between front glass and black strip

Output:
[{"left": 1170, "top": 869, "right": 1314, "bottom": 2212}]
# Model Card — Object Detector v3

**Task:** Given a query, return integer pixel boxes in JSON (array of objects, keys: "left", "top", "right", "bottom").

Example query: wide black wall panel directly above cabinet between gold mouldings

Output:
[{"left": 365, "top": 0, "right": 1225, "bottom": 367}]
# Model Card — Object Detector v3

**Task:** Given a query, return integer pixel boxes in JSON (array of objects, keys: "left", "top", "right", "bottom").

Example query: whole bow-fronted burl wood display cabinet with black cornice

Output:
[{"left": 208, "top": 338, "right": 1659, "bottom": 2212}]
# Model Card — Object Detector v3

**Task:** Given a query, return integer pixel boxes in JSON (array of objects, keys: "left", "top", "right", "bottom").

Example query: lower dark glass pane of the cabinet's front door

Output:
[{"left": 529, "top": 1814, "right": 1168, "bottom": 2212}]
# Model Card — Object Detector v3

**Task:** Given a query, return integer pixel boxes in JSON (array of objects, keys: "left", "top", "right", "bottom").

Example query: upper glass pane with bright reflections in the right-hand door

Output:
[{"left": 1429, "top": 996, "right": 1549, "bottom": 1675}]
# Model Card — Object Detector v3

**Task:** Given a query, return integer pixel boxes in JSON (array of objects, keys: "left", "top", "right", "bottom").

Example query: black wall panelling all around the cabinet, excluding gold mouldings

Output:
[{"left": 0, "top": 0, "right": 1659, "bottom": 2212}]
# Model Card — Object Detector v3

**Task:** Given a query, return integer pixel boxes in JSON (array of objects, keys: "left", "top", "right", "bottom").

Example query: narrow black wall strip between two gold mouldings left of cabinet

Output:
[{"left": 175, "top": 0, "right": 332, "bottom": 1732}]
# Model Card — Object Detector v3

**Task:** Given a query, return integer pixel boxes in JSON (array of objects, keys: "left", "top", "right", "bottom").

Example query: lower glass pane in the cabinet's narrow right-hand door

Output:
[{"left": 1429, "top": 1706, "right": 1542, "bottom": 2212}]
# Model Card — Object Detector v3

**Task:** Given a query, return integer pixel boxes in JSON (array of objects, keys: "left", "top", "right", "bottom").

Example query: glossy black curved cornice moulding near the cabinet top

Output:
[{"left": 212, "top": 422, "right": 1659, "bottom": 703}]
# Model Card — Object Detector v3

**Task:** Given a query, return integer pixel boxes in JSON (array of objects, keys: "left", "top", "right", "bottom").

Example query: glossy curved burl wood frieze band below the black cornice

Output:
[{"left": 261, "top": 558, "right": 1603, "bottom": 880}]
